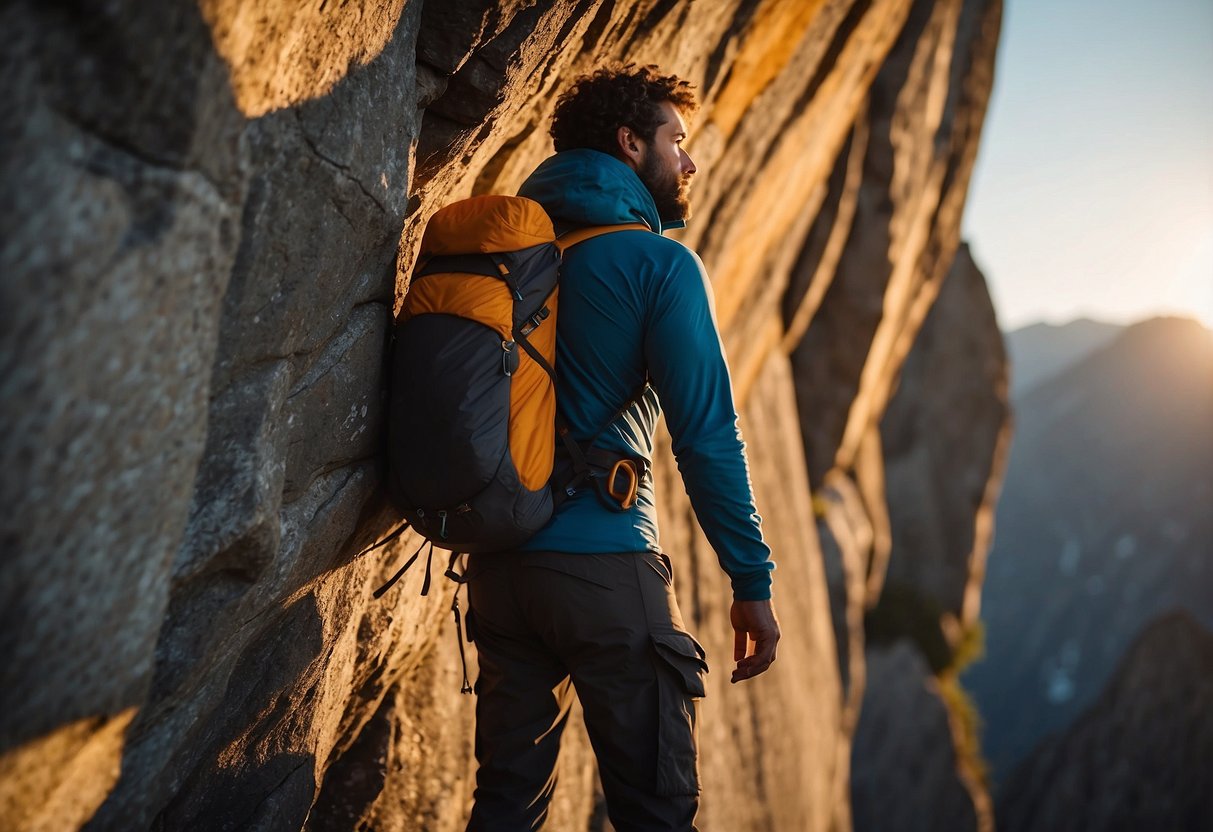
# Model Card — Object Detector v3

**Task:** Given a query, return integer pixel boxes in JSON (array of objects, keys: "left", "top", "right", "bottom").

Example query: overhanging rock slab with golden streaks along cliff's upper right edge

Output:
[{"left": 782, "top": 2, "right": 1001, "bottom": 719}]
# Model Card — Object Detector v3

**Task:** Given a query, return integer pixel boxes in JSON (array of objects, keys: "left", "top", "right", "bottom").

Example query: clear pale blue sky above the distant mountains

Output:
[{"left": 963, "top": 0, "right": 1213, "bottom": 331}]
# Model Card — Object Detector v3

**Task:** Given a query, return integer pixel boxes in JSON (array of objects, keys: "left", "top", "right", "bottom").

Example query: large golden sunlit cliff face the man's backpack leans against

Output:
[{"left": 0, "top": 0, "right": 1001, "bottom": 831}]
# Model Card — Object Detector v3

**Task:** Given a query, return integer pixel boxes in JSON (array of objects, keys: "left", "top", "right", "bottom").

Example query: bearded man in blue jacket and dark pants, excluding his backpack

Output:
[{"left": 467, "top": 65, "right": 779, "bottom": 832}]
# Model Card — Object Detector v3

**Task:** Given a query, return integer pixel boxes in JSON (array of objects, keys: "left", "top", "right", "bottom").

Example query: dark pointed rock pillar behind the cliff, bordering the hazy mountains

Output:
[{"left": 852, "top": 246, "right": 1010, "bottom": 830}]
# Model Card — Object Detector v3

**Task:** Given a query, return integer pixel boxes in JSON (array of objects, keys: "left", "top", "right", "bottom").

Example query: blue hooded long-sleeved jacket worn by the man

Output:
[{"left": 518, "top": 149, "right": 774, "bottom": 600}]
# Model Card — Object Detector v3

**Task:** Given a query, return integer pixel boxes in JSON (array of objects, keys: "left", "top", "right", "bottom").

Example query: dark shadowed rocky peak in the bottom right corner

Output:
[{"left": 998, "top": 612, "right": 1213, "bottom": 832}]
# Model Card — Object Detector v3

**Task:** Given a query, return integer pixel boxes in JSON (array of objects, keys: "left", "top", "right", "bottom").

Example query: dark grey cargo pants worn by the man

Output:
[{"left": 467, "top": 552, "right": 707, "bottom": 832}]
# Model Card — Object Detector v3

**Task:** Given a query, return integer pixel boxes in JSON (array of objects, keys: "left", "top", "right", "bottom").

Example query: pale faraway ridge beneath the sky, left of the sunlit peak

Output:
[{"left": 1006, "top": 318, "right": 1124, "bottom": 399}]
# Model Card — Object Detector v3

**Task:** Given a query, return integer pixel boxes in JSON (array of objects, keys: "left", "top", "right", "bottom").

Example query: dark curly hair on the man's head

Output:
[{"left": 549, "top": 63, "right": 699, "bottom": 155}]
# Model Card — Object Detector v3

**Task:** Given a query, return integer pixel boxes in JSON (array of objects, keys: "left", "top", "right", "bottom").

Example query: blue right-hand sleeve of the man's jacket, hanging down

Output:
[{"left": 644, "top": 245, "right": 774, "bottom": 600}]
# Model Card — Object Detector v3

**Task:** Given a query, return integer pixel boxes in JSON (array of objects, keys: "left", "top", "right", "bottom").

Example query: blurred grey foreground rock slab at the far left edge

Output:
[{"left": 0, "top": 2, "right": 243, "bottom": 827}]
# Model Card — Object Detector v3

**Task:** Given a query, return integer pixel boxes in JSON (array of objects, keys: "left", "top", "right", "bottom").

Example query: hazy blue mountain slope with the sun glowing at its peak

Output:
[{"left": 964, "top": 318, "right": 1213, "bottom": 780}]
